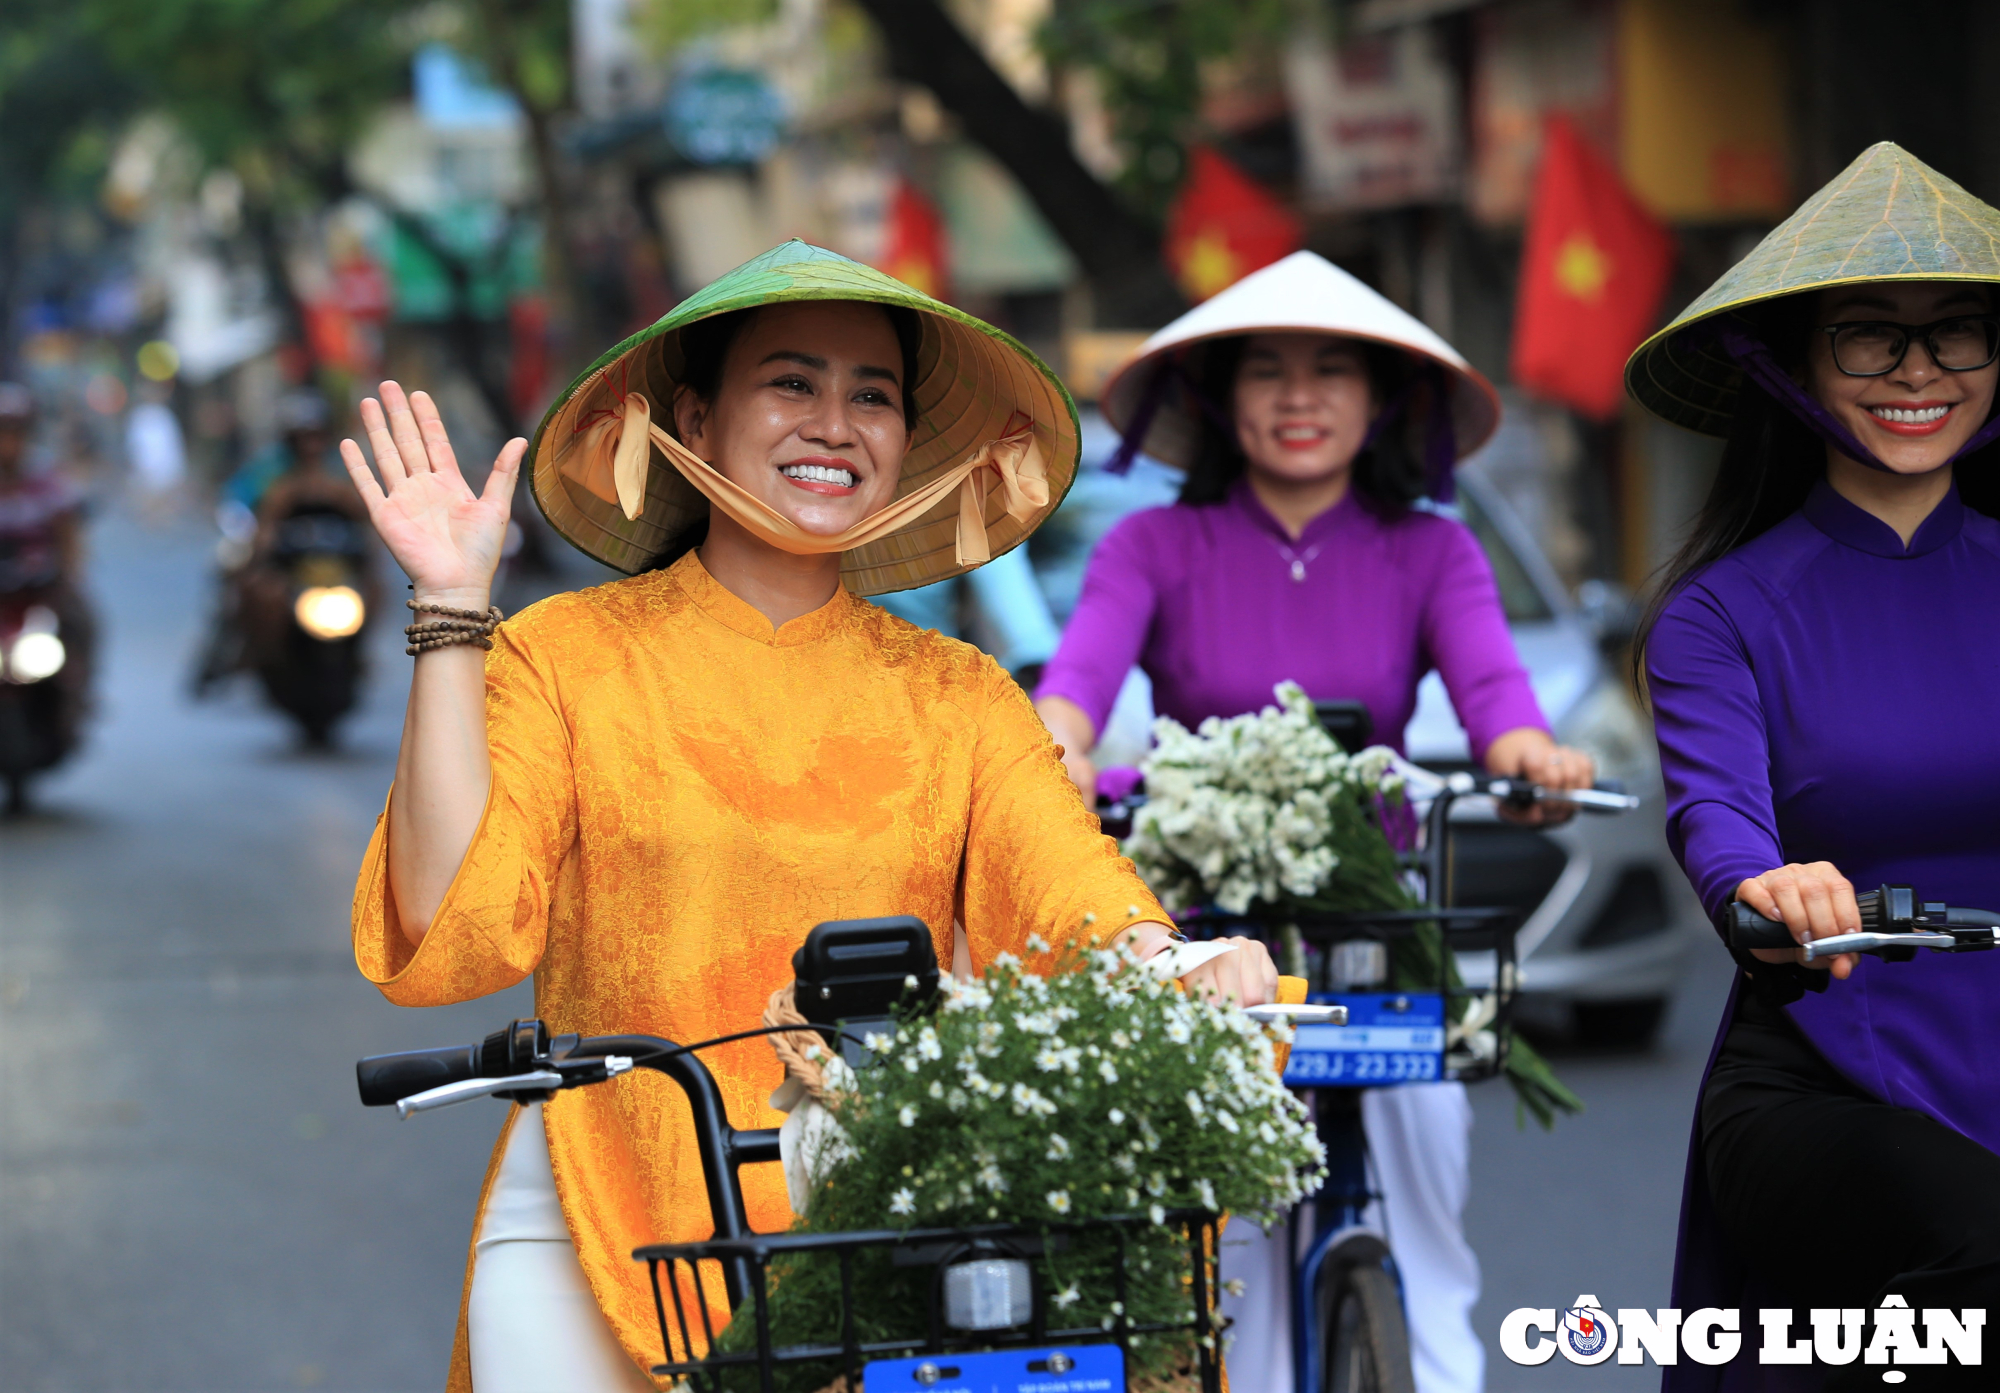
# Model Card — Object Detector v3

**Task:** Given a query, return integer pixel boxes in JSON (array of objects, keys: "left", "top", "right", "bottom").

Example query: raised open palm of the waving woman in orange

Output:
[{"left": 340, "top": 382, "right": 528, "bottom": 608}]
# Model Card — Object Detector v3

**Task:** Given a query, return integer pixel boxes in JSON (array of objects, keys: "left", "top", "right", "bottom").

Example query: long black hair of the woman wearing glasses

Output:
[{"left": 1632, "top": 294, "right": 2000, "bottom": 672}]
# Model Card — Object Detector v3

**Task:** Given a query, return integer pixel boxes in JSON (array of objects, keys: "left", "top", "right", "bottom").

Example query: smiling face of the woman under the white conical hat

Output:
[{"left": 1234, "top": 334, "right": 1376, "bottom": 484}]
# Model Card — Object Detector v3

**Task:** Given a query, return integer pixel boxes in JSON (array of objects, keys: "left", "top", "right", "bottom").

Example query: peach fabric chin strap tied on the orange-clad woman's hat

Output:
[{"left": 562, "top": 392, "right": 1048, "bottom": 566}]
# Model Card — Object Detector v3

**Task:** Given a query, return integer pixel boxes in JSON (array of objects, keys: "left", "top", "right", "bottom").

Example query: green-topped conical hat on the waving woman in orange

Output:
[{"left": 530, "top": 240, "right": 1078, "bottom": 594}]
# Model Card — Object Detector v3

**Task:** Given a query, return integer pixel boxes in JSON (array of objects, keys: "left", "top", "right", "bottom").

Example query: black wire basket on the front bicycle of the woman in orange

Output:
[{"left": 632, "top": 1209, "right": 1222, "bottom": 1393}]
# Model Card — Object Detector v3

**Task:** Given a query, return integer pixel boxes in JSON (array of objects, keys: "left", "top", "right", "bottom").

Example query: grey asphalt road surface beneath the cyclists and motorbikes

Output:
[{"left": 0, "top": 514, "right": 1726, "bottom": 1393}]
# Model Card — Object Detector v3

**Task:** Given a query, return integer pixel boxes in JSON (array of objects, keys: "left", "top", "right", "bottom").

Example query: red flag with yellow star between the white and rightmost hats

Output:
[{"left": 1514, "top": 116, "right": 1674, "bottom": 420}]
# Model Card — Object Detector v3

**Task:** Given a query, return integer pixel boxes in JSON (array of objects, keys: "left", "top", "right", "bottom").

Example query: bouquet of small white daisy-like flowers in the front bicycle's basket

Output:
[{"left": 720, "top": 939, "right": 1326, "bottom": 1389}]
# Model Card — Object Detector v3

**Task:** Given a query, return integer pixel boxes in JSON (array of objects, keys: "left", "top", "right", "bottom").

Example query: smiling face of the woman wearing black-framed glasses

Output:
[{"left": 1806, "top": 282, "right": 2000, "bottom": 474}]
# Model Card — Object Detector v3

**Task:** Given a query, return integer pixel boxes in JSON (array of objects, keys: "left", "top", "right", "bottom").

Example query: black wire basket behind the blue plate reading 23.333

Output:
[{"left": 1180, "top": 909, "right": 1520, "bottom": 1087}]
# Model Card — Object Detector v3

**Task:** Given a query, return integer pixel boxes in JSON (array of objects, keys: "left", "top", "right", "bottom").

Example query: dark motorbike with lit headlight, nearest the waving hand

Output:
[{"left": 238, "top": 500, "right": 370, "bottom": 747}]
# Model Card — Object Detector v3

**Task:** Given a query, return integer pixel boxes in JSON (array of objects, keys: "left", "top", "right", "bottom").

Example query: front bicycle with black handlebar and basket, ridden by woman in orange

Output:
[{"left": 356, "top": 919, "right": 1342, "bottom": 1393}]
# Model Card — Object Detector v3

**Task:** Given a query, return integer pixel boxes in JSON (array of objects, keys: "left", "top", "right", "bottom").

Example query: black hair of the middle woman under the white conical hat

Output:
[{"left": 1164, "top": 338, "right": 1434, "bottom": 518}]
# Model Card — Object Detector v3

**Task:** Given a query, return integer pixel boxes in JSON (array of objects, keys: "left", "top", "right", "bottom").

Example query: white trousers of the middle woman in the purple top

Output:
[{"left": 1222, "top": 1083, "right": 1486, "bottom": 1393}]
